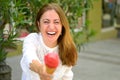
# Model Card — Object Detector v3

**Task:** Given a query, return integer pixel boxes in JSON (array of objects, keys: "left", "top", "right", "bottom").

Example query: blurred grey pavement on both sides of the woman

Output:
[{"left": 7, "top": 38, "right": 120, "bottom": 80}]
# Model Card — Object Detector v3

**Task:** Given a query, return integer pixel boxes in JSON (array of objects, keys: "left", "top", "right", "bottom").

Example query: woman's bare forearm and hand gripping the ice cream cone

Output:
[{"left": 30, "top": 60, "right": 52, "bottom": 80}]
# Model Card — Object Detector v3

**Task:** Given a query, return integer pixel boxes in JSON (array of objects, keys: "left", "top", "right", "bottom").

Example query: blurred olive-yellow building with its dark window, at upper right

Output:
[{"left": 87, "top": 0, "right": 120, "bottom": 40}]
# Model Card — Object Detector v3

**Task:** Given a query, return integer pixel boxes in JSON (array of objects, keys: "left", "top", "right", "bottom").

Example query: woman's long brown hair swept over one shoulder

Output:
[{"left": 36, "top": 3, "right": 78, "bottom": 66}]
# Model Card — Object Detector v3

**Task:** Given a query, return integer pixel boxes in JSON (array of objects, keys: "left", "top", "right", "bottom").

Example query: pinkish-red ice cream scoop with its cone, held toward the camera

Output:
[{"left": 44, "top": 53, "right": 59, "bottom": 74}]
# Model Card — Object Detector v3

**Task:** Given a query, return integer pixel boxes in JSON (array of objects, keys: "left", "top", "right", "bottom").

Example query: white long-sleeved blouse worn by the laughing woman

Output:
[{"left": 20, "top": 33, "right": 73, "bottom": 80}]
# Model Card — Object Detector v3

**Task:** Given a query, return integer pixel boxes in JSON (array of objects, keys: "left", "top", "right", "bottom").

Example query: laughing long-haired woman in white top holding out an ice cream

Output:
[{"left": 21, "top": 3, "right": 77, "bottom": 80}]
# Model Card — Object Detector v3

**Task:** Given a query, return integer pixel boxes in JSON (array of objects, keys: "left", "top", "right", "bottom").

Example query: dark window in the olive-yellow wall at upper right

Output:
[{"left": 102, "top": 0, "right": 117, "bottom": 28}]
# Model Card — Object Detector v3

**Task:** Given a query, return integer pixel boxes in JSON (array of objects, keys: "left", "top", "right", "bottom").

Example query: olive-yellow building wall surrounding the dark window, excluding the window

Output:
[{"left": 87, "top": 0, "right": 117, "bottom": 40}]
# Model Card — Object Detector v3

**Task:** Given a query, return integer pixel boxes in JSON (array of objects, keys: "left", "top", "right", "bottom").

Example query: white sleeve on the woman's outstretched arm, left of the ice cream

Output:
[{"left": 20, "top": 33, "right": 40, "bottom": 80}]
